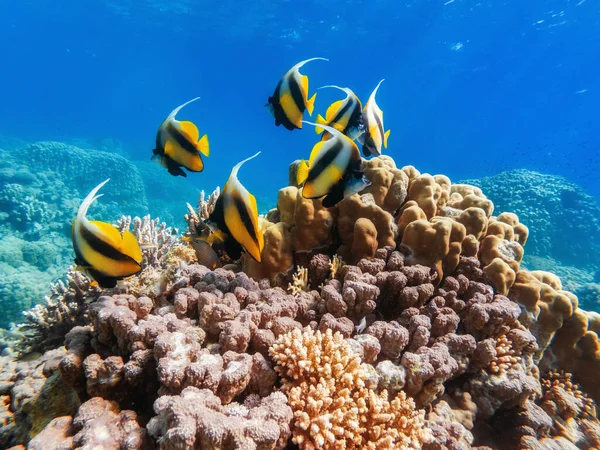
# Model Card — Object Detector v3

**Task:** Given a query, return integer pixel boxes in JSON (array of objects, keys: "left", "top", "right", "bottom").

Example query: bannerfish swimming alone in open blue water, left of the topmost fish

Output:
[{"left": 151, "top": 97, "right": 210, "bottom": 177}]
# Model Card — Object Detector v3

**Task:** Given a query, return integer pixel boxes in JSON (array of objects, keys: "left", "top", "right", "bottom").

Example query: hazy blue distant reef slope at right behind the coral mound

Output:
[{"left": 464, "top": 169, "right": 600, "bottom": 310}]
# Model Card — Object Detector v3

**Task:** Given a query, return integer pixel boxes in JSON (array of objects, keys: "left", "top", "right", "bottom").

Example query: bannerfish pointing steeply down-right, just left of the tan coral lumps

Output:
[{"left": 208, "top": 152, "right": 265, "bottom": 262}]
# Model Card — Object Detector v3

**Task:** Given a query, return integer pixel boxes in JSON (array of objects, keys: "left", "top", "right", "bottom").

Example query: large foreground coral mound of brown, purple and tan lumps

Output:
[{"left": 0, "top": 157, "right": 600, "bottom": 450}]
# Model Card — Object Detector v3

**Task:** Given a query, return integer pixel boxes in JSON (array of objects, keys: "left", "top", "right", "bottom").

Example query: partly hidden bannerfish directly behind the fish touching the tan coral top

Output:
[{"left": 315, "top": 86, "right": 364, "bottom": 141}]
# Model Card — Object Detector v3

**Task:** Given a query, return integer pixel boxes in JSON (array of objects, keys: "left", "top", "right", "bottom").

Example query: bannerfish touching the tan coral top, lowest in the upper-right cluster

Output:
[{"left": 296, "top": 122, "right": 371, "bottom": 208}]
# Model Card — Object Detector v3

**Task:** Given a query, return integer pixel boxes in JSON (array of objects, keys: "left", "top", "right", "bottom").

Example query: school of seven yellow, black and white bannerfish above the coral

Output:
[{"left": 71, "top": 58, "right": 390, "bottom": 288}]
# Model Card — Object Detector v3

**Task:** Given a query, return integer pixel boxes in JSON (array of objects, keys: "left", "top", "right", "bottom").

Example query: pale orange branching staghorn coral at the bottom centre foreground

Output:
[{"left": 269, "top": 328, "right": 429, "bottom": 449}]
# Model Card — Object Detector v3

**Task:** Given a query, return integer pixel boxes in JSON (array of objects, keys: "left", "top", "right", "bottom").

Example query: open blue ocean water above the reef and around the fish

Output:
[{"left": 0, "top": 0, "right": 600, "bottom": 199}]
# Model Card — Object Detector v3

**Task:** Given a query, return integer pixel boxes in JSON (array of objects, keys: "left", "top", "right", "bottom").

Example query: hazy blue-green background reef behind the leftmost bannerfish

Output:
[{"left": 0, "top": 141, "right": 207, "bottom": 328}]
